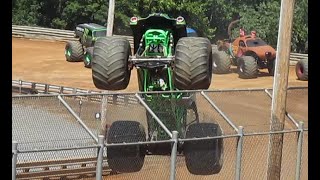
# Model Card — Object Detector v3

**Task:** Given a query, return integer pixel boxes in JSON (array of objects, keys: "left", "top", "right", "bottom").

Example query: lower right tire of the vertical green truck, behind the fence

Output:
[{"left": 183, "top": 123, "right": 223, "bottom": 175}]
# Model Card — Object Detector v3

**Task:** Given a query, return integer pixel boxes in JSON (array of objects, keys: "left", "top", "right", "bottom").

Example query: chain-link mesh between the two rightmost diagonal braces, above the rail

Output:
[{"left": 207, "top": 90, "right": 295, "bottom": 133}]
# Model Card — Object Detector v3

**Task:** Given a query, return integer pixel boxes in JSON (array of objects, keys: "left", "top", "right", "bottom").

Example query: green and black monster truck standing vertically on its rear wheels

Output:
[{"left": 92, "top": 13, "right": 223, "bottom": 175}]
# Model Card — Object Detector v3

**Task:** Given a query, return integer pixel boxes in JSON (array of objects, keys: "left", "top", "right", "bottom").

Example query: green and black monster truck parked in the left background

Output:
[{"left": 65, "top": 23, "right": 107, "bottom": 68}]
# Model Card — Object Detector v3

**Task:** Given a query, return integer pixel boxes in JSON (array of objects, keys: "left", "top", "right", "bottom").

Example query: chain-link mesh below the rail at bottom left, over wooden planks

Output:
[{"left": 17, "top": 148, "right": 102, "bottom": 179}]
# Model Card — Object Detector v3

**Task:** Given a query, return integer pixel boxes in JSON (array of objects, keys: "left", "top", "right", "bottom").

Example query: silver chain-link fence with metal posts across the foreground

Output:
[{"left": 12, "top": 88, "right": 308, "bottom": 179}]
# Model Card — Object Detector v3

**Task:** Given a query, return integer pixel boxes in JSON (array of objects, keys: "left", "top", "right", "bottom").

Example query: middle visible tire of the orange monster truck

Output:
[{"left": 237, "top": 56, "right": 258, "bottom": 79}]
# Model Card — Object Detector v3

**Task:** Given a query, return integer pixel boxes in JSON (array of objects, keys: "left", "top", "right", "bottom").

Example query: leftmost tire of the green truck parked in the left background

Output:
[{"left": 65, "top": 41, "right": 83, "bottom": 62}]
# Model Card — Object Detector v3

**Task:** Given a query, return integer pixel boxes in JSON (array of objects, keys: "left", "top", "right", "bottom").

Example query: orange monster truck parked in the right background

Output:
[{"left": 213, "top": 20, "right": 276, "bottom": 79}]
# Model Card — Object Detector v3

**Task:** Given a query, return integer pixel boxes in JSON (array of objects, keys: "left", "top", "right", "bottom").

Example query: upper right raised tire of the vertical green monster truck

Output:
[{"left": 174, "top": 37, "right": 212, "bottom": 90}]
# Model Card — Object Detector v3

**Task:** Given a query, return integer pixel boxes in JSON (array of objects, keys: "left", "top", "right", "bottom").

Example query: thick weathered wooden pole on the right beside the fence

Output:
[{"left": 267, "top": 0, "right": 295, "bottom": 180}]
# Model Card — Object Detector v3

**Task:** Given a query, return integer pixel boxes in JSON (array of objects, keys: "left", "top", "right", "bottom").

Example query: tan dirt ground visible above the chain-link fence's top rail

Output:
[{"left": 12, "top": 38, "right": 308, "bottom": 92}]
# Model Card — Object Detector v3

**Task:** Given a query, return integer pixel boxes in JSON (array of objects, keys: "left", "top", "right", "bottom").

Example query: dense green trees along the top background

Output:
[{"left": 12, "top": 0, "right": 308, "bottom": 53}]
